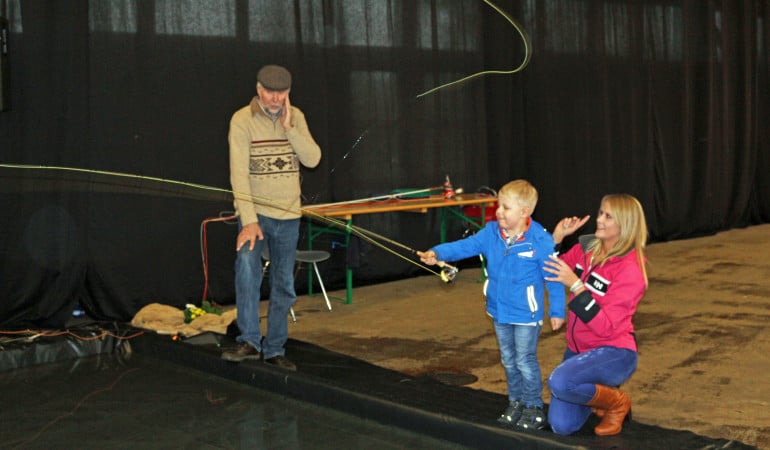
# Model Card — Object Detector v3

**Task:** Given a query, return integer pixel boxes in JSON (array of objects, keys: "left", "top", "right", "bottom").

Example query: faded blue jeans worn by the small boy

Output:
[{"left": 494, "top": 321, "right": 543, "bottom": 408}]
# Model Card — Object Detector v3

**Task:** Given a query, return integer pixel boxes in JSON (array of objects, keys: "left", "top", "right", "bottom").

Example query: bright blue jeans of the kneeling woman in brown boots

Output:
[{"left": 548, "top": 347, "right": 638, "bottom": 435}]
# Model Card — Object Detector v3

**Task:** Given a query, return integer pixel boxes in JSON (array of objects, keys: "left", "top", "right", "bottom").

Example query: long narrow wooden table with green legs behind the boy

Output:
[{"left": 302, "top": 194, "right": 497, "bottom": 303}]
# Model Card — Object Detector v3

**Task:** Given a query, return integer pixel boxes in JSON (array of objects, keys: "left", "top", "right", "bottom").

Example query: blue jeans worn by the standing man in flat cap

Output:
[{"left": 235, "top": 216, "right": 299, "bottom": 359}]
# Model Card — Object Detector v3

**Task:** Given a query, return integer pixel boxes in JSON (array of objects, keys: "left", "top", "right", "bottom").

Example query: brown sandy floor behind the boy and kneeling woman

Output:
[{"left": 282, "top": 225, "right": 770, "bottom": 449}]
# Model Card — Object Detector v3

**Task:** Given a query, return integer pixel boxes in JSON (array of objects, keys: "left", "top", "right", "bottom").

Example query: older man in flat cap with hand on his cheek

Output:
[{"left": 222, "top": 65, "right": 321, "bottom": 370}]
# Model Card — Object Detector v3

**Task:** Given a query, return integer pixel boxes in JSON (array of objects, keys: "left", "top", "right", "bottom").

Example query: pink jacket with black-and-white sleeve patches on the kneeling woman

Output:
[{"left": 561, "top": 236, "right": 647, "bottom": 353}]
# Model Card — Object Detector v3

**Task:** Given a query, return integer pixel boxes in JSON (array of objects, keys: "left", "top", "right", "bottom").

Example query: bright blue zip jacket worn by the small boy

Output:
[{"left": 431, "top": 220, "right": 565, "bottom": 324}]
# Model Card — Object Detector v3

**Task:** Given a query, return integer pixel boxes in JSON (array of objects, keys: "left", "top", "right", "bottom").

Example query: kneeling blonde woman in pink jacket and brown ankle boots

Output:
[{"left": 545, "top": 194, "right": 647, "bottom": 435}]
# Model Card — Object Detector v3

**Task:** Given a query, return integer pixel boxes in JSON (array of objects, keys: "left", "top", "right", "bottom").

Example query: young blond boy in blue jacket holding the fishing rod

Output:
[{"left": 417, "top": 180, "right": 565, "bottom": 429}]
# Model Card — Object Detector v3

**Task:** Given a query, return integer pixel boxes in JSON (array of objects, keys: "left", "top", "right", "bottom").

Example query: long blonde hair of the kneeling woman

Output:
[{"left": 588, "top": 194, "right": 647, "bottom": 284}]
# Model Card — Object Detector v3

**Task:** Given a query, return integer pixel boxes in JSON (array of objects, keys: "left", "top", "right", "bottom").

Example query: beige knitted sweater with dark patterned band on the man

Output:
[{"left": 228, "top": 97, "right": 321, "bottom": 226}]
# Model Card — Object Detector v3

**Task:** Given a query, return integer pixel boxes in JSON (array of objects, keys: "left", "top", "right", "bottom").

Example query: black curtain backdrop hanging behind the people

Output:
[{"left": 0, "top": 0, "right": 770, "bottom": 328}]
